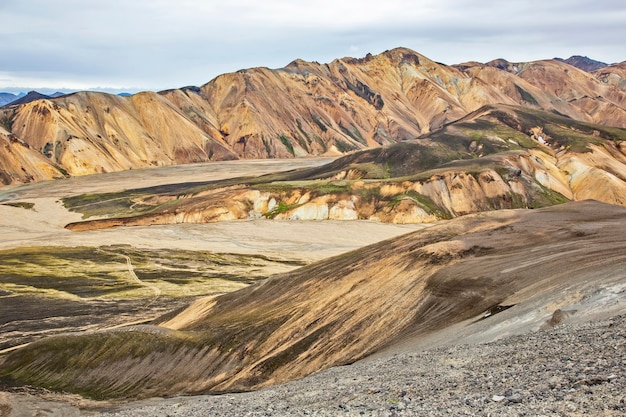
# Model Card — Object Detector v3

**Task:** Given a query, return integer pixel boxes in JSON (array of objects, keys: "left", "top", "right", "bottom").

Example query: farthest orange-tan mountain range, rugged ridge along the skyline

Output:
[{"left": 0, "top": 48, "right": 626, "bottom": 184}]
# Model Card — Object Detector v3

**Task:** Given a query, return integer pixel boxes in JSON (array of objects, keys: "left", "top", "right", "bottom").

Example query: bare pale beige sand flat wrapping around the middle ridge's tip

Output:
[{"left": 0, "top": 159, "right": 427, "bottom": 261}]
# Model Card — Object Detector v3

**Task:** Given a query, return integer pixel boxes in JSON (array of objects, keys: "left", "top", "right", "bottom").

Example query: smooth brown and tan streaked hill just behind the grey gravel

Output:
[{"left": 0, "top": 201, "right": 626, "bottom": 398}]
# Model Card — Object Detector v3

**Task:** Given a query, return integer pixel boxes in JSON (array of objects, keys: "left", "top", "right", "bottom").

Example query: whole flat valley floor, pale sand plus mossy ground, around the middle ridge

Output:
[{"left": 0, "top": 159, "right": 420, "bottom": 353}]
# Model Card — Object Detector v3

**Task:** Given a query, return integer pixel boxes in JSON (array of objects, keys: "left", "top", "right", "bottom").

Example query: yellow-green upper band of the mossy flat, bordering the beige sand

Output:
[{"left": 0, "top": 245, "right": 302, "bottom": 299}]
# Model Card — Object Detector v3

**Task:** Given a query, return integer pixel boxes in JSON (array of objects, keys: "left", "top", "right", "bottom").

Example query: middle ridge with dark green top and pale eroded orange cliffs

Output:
[{"left": 63, "top": 106, "right": 626, "bottom": 231}]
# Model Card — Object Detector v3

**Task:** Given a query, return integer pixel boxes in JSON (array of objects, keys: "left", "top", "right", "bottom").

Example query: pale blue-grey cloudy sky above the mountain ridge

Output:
[{"left": 0, "top": 0, "right": 626, "bottom": 92}]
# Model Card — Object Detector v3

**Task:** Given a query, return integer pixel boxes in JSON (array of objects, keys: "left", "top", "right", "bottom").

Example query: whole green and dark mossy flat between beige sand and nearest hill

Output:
[{"left": 0, "top": 245, "right": 303, "bottom": 351}]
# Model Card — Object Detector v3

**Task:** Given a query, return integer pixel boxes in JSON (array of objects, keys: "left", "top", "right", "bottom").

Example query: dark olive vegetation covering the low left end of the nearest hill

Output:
[{"left": 0, "top": 331, "right": 201, "bottom": 400}]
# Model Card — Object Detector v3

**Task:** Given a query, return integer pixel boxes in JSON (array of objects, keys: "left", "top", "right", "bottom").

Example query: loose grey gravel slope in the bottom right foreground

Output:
[{"left": 92, "top": 315, "right": 626, "bottom": 417}]
